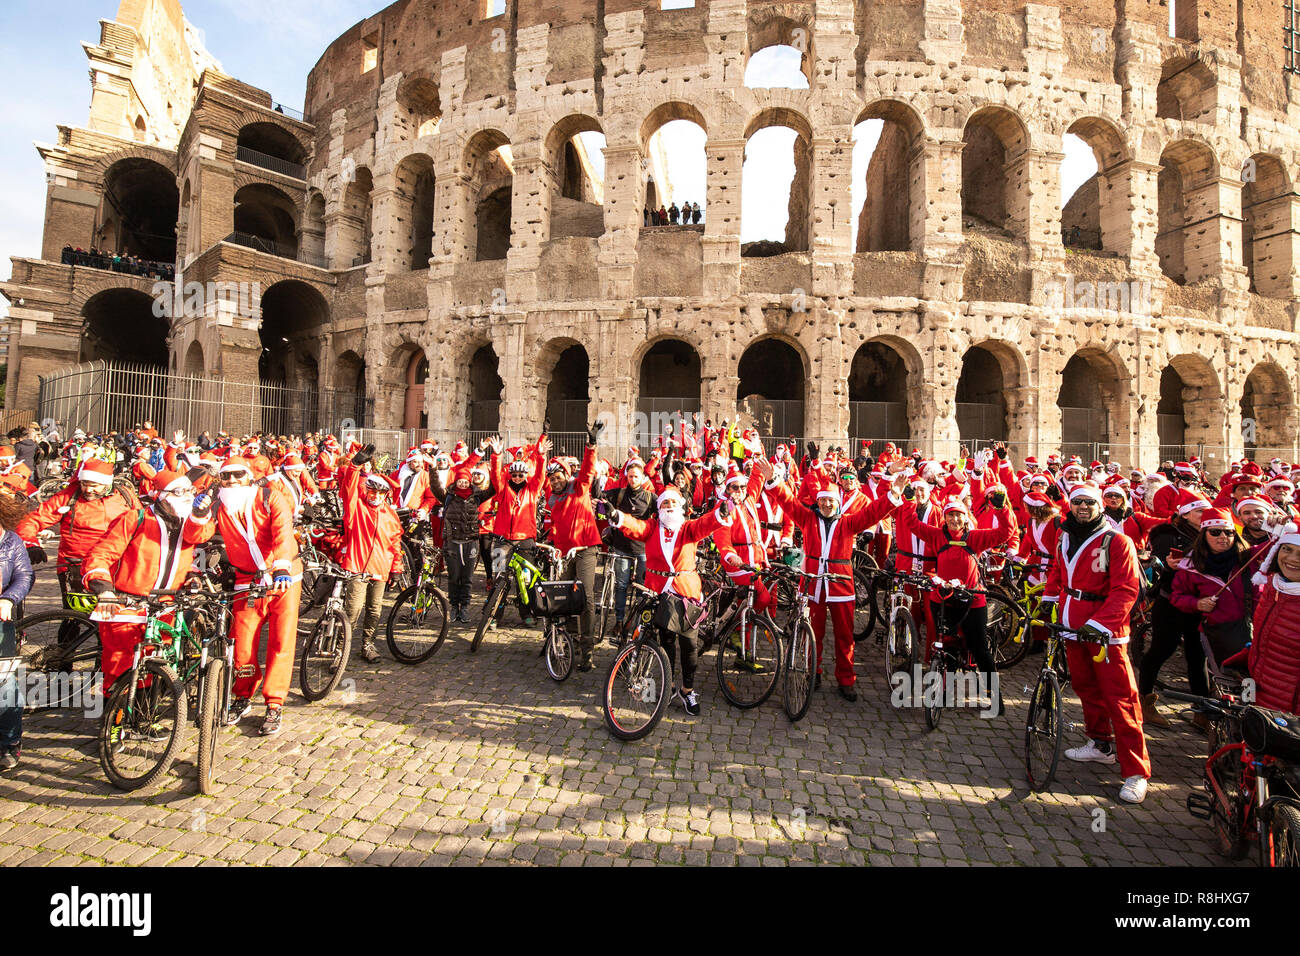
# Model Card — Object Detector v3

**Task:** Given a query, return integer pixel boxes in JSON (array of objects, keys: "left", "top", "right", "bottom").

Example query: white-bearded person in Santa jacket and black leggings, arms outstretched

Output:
[{"left": 608, "top": 486, "right": 732, "bottom": 717}]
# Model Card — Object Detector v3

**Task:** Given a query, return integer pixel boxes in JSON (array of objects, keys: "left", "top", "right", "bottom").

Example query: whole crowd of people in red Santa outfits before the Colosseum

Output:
[{"left": 0, "top": 418, "right": 1300, "bottom": 803}]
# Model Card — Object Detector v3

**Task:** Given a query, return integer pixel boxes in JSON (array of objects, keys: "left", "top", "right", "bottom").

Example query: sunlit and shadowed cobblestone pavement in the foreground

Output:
[{"left": 0, "top": 561, "right": 1226, "bottom": 866}]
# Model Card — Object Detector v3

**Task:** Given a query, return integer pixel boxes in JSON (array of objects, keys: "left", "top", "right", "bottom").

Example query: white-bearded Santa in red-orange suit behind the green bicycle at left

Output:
[{"left": 82, "top": 468, "right": 216, "bottom": 697}]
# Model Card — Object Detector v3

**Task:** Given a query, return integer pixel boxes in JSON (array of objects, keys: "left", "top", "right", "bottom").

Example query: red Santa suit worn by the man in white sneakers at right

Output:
[{"left": 1044, "top": 520, "right": 1151, "bottom": 778}]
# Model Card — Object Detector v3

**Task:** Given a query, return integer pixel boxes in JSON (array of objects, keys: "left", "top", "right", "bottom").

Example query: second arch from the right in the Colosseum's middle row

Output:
[{"left": 1156, "top": 139, "right": 1225, "bottom": 285}]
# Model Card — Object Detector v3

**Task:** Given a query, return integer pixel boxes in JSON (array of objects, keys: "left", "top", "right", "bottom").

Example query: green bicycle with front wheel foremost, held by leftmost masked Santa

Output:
[{"left": 99, "top": 591, "right": 209, "bottom": 791}]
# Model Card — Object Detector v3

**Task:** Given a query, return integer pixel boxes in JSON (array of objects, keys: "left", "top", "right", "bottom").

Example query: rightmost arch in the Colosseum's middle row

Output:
[{"left": 1242, "top": 153, "right": 1296, "bottom": 299}]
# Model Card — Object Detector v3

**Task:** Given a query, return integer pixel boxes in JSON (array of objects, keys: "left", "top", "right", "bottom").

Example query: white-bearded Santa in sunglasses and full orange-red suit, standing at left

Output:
[{"left": 194, "top": 458, "right": 303, "bottom": 736}]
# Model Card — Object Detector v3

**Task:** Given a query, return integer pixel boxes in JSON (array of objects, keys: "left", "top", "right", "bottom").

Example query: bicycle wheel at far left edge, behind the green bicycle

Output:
[{"left": 14, "top": 610, "right": 100, "bottom": 711}]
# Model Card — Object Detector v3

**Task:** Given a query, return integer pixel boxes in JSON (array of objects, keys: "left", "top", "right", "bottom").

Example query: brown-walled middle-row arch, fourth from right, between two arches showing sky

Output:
[{"left": 962, "top": 107, "right": 1030, "bottom": 239}]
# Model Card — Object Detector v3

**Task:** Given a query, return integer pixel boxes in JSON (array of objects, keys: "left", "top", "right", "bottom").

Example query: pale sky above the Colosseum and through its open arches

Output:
[{"left": 0, "top": 0, "right": 1096, "bottom": 317}]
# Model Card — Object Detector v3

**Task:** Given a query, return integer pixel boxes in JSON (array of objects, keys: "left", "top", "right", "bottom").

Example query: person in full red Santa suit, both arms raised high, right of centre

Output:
[{"left": 755, "top": 455, "right": 907, "bottom": 701}]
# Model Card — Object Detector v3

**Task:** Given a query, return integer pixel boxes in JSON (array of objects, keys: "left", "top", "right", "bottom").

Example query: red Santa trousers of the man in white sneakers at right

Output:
[{"left": 1065, "top": 641, "right": 1151, "bottom": 778}]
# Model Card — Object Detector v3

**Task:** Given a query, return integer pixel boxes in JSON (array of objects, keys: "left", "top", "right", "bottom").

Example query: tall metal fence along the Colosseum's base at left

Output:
[{"left": 38, "top": 362, "right": 373, "bottom": 436}]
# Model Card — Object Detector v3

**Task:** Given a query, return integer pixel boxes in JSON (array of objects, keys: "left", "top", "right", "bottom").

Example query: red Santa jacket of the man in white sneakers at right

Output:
[{"left": 1043, "top": 522, "right": 1138, "bottom": 644}]
